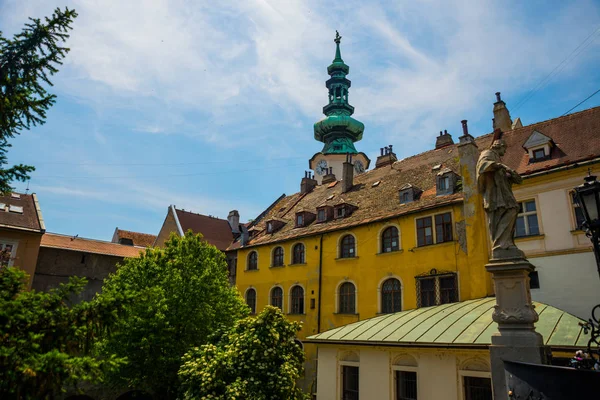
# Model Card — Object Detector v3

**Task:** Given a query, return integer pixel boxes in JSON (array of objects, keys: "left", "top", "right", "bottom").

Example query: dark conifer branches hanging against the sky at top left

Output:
[{"left": 0, "top": 8, "right": 77, "bottom": 193}]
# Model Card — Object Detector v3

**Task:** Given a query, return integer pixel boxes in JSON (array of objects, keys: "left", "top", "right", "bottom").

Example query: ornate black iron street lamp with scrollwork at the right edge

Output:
[{"left": 575, "top": 173, "right": 600, "bottom": 363}]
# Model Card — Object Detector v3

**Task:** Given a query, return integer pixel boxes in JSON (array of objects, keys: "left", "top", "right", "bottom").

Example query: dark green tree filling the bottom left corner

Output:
[{"left": 0, "top": 266, "right": 124, "bottom": 399}]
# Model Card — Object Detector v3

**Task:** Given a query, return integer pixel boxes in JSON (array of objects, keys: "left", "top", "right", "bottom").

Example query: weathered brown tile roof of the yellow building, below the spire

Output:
[{"left": 229, "top": 142, "right": 462, "bottom": 250}]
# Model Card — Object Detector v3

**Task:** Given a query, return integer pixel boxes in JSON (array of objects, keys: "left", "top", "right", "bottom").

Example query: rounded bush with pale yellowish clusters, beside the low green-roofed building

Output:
[{"left": 179, "top": 306, "right": 308, "bottom": 400}]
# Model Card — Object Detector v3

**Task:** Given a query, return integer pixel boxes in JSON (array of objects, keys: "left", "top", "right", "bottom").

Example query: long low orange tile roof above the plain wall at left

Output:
[{"left": 40, "top": 233, "right": 144, "bottom": 258}]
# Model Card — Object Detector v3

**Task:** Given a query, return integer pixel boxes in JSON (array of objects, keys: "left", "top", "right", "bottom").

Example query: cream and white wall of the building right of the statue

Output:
[{"left": 513, "top": 169, "right": 600, "bottom": 320}]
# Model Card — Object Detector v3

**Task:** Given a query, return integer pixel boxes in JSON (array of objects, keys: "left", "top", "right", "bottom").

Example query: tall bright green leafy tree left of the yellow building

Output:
[{"left": 101, "top": 231, "right": 249, "bottom": 399}]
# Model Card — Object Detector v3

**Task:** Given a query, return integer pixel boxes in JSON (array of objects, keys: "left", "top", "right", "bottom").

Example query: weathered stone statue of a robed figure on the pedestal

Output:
[{"left": 477, "top": 130, "right": 524, "bottom": 259}]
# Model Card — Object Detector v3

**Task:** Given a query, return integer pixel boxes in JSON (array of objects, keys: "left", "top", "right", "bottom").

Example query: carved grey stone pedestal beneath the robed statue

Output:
[{"left": 485, "top": 258, "right": 547, "bottom": 400}]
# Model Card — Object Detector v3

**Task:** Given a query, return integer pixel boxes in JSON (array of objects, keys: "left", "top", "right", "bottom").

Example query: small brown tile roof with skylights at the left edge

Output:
[{"left": 0, "top": 193, "right": 45, "bottom": 232}]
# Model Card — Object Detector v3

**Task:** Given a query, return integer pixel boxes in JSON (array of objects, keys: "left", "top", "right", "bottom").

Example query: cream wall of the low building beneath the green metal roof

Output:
[{"left": 317, "top": 345, "right": 489, "bottom": 400}]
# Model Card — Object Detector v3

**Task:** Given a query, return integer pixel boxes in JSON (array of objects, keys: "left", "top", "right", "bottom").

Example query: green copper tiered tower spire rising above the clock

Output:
[{"left": 314, "top": 31, "right": 365, "bottom": 154}]
